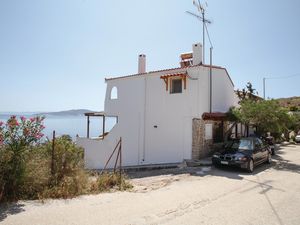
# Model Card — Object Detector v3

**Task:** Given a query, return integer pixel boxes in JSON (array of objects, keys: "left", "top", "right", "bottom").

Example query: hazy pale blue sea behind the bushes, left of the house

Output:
[{"left": 0, "top": 112, "right": 116, "bottom": 140}]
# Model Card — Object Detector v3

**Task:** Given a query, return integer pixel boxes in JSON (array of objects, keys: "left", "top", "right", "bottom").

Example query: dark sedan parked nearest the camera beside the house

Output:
[{"left": 212, "top": 137, "right": 272, "bottom": 173}]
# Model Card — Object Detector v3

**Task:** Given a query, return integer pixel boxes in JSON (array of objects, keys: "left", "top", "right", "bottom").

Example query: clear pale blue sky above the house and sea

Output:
[{"left": 0, "top": 0, "right": 300, "bottom": 111}]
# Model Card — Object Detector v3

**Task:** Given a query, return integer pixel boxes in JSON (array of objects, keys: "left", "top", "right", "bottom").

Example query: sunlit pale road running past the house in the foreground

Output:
[{"left": 0, "top": 145, "right": 300, "bottom": 225}]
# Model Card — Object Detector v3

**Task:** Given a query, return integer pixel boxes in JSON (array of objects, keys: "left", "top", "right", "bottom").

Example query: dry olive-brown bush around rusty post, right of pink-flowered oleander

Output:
[{"left": 39, "top": 135, "right": 88, "bottom": 198}]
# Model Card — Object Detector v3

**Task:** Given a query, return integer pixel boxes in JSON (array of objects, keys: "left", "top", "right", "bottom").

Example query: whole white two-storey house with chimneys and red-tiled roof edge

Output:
[{"left": 77, "top": 44, "right": 237, "bottom": 169}]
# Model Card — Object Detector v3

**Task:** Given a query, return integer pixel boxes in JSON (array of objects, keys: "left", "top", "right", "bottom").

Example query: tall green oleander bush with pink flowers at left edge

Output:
[{"left": 0, "top": 116, "right": 44, "bottom": 201}]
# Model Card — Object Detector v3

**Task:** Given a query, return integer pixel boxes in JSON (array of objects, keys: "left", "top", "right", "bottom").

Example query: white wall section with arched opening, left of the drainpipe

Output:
[{"left": 104, "top": 77, "right": 145, "bottom": 166}]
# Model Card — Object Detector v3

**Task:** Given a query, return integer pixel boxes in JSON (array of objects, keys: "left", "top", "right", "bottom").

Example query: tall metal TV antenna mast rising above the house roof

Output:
[{"left": 186, "top": 0, "right": 212, "bottom": 64}]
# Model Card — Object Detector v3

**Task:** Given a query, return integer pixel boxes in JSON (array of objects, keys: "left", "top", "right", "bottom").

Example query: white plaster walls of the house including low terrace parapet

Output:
[{"left": 78, "top": 66, "right": 237, "bottom": 169}]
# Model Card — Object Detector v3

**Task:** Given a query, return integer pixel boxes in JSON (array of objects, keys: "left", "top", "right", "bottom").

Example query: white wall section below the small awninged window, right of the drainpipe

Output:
[{"left": 144, "top": 69, "right": 197, "bottom": 164}]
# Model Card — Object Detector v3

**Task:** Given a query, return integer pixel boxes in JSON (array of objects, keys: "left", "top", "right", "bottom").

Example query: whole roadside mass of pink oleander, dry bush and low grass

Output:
[{"left": 0, "top": 116, "right": 131, "bottom": 202}]
